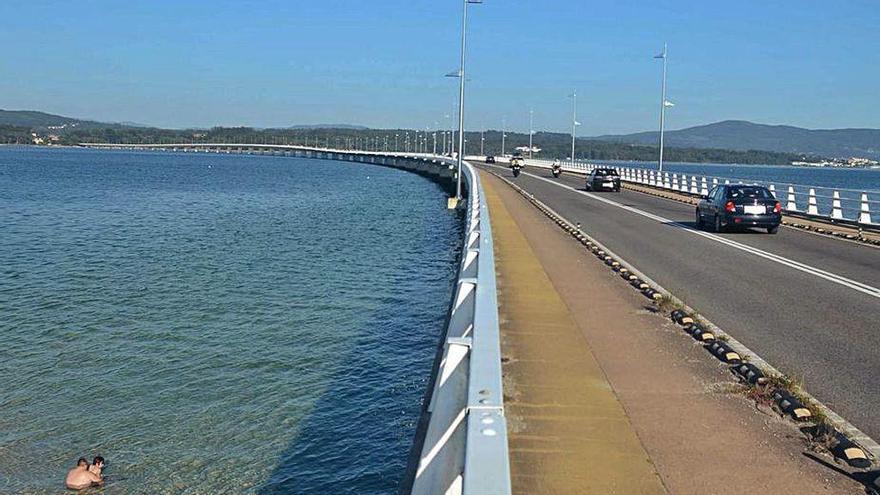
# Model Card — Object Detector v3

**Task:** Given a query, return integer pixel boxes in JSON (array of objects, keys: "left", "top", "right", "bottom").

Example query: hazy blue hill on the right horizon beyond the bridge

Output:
[{"left": 593, "top": 120, "right": 880, "bottom": 158}]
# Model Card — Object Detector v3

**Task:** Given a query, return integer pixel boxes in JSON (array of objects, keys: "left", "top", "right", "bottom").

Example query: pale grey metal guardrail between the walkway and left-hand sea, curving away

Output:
[{"left": 82, "top": 143, "right": 511, "bottom": 495}]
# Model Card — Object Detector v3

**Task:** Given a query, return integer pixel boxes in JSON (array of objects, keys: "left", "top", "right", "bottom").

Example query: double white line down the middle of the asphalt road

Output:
[{"left": 498, "top": 167, "right": 880, "bottom": 299}]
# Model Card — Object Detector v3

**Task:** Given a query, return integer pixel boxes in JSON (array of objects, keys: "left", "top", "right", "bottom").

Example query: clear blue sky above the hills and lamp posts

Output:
[{"left": 0, "top": 0, "right": 880, "bottom": 135}]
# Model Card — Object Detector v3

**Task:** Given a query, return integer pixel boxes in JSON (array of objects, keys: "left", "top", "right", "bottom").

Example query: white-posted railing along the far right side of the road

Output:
[{"left": 496, "top": 157, "right": 880, "bottom": 230}]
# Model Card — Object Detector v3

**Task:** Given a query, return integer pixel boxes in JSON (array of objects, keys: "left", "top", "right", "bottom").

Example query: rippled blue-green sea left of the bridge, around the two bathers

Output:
[{"left": 0, "top": 148, "right": 462, "bottom": 494}]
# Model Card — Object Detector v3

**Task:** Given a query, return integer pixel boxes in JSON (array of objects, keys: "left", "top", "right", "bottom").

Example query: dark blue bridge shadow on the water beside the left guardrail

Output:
[{"left": 257, "top": 203, "right": 458, "bottom": 495}]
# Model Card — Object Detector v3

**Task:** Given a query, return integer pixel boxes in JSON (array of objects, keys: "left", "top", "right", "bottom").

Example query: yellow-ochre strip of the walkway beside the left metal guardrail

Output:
[{"left": 483, "top": 174, "right": 666, "bottom": 494}]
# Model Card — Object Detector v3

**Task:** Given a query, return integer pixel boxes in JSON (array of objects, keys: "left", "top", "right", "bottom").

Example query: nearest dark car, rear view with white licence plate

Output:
[{"left": 696, "top": 184, "right": 782, "bottom": 234}]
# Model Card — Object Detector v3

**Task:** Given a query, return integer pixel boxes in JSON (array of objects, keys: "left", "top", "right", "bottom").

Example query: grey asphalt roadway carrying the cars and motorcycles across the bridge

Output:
[{"left": 482, "top": 167, "right": 880, "bottom": 440}]
